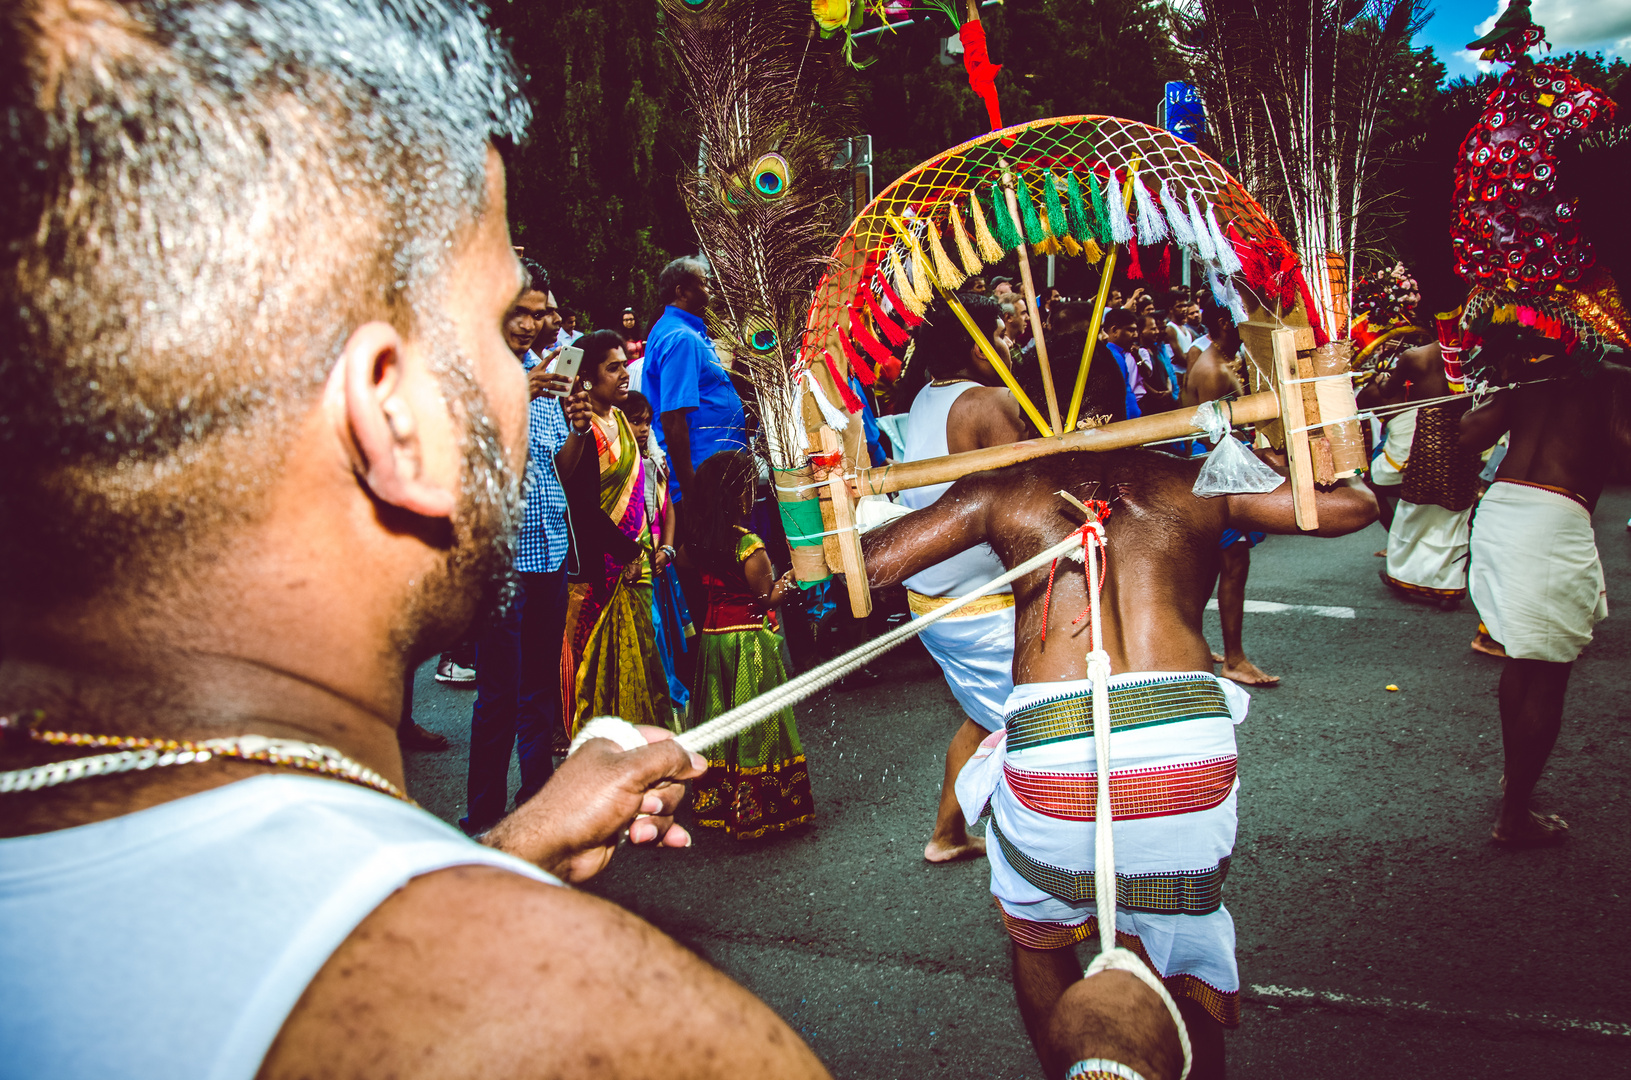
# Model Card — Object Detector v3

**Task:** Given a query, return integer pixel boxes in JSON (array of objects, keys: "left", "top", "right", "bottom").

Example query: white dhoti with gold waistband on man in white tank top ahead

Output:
[{"left": 907, "top": 592, "right": 1014, "bottom": 731}]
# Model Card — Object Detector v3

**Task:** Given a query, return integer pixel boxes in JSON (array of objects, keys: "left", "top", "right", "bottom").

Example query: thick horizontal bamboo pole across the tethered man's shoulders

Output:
[{"left": 855, "top": 390, "right": 1280, "bottom": 496}]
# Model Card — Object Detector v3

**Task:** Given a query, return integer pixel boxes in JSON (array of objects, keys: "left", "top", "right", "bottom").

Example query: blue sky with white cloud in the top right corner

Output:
[{"left": 1416, "top": 0, "right": 1631, "bottom": 78}]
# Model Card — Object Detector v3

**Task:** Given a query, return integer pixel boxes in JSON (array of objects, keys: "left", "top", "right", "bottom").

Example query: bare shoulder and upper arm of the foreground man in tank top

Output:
[{"left": 261, "top": 866, "right": 825, "bottom": 1080}]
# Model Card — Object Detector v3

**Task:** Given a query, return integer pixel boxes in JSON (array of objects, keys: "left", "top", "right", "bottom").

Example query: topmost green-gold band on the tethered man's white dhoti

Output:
[{"left": 1006, "top": 672, "right": 1230, "bottom": 756}]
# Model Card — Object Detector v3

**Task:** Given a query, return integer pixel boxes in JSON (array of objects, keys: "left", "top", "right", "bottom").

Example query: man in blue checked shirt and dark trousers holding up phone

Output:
[{"left": 458, "top": 259, "right": 589, "bottom": 835}]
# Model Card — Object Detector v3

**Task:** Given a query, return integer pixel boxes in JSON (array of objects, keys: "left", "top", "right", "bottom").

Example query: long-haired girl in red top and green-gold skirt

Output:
[{"left": 680, "top": 450, "right": 816, "bottom": 840}]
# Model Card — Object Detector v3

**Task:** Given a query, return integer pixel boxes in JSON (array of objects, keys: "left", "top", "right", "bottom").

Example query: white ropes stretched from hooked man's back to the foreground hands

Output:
[{"left": 571, "top": 512, "right": 1191, "bottom": 1080}]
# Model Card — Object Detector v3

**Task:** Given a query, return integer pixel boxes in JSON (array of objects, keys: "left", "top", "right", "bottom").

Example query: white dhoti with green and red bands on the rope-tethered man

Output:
[{"left": 957, "top": 672, "right": 1249, "bottom": 1026}]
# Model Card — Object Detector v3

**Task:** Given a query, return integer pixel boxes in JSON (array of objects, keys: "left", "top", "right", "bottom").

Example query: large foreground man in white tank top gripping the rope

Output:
[{"left": 0, "top": 0, "right": 825, "bottom": 1077}]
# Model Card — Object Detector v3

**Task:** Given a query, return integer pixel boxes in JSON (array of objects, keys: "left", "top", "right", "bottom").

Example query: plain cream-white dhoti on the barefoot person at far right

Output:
[{"left": 1468, "top": 480, "right": 1608, "bottom": 664}]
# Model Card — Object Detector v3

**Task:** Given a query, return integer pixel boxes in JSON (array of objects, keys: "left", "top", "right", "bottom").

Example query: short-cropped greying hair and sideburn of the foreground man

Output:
[{"left": 0, "top": 0, "right": 530, "bottom": 603}]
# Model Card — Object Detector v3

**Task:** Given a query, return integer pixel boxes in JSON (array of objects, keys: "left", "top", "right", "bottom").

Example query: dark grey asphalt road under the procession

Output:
[{"left": 397, "top": 488, "right": 1631, "bottom": 1080}]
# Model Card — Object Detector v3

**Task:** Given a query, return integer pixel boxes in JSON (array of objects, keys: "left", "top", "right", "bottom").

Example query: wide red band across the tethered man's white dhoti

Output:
[{"left": 1003, "top": 757, "right": 1235, "bottom": 821}]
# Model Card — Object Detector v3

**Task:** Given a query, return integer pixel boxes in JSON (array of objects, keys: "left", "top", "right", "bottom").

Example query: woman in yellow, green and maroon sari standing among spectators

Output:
[{"left": 561, "top": 330, "right": 674, "bottom": 736}]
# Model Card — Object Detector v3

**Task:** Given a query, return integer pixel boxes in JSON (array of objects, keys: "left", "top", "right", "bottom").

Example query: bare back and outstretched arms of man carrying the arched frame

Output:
[{"left": 864, "top": 450, "right": 1377, "bottom": 684}]
